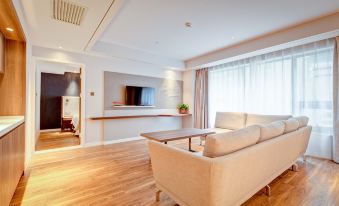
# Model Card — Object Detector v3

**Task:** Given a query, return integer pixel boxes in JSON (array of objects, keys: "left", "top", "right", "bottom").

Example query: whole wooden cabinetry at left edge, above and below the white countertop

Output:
[{"left": 0, "top": 0, "right": 26, "bottom": 206}]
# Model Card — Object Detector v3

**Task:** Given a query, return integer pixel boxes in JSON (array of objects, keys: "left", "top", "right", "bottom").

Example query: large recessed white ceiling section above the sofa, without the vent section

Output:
[{"left": 100, "top": 0, "right": 339, "bottom": 60}]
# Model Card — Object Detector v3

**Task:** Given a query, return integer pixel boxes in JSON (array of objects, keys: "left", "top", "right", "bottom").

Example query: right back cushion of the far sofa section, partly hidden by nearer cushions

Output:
[{"left": 246, "top": 114, "right": 292, "bottom": 127}]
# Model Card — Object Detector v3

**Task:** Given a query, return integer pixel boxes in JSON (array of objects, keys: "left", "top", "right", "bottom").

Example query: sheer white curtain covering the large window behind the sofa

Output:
[{"left": 209, "top": 39, "right": 334, "bottom": 158}]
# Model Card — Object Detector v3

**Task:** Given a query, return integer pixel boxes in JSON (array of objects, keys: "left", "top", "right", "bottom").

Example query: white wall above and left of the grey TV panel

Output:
[{"left": 33, "top": 46, "right": 182, "bottom": 145}]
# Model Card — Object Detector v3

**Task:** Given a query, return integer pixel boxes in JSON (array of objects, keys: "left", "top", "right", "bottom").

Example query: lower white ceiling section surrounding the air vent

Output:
[{"left": 21, "top": 0, "right": 113, "bottom": 51}]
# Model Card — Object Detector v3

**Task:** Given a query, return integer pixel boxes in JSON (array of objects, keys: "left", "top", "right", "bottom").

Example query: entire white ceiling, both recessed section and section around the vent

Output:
[{"left": 21, "top": 0, "right": 339, "bottom": 68}]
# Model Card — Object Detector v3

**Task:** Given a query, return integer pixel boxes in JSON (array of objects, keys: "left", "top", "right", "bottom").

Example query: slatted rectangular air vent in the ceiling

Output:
[{"left": 53, "top": 0, "right": 86, "bottom": 25}]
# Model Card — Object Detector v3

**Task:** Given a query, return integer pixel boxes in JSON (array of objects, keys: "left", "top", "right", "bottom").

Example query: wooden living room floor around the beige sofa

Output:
[{"left": 11, "top": 140, "right": 339, "bottom": 206}]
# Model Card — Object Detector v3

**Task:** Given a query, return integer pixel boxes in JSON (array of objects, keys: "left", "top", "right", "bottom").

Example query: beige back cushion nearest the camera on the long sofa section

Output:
[{"left": 203, "top": 125, "right": 260, "bottom": 157}]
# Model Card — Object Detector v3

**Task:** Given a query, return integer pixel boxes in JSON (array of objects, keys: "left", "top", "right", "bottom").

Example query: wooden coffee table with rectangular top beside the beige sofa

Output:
[{"left": 140, "top": 128, "right": 215, "bottom": 152}]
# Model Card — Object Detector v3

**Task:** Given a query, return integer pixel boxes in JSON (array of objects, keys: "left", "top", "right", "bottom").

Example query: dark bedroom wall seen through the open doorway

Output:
[{"left": 40, "top": 72, "right": 80, "bottom": 129}]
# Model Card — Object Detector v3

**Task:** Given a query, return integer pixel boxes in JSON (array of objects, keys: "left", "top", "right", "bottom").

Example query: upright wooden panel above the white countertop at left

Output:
[{"left": 0, "top": 39, "right": 26, "bottom": 116}]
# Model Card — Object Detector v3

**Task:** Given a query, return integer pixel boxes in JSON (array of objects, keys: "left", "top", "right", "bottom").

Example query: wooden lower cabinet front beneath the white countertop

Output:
[{"left": 0, "top": 124, "right": 25, "bottom": 206}]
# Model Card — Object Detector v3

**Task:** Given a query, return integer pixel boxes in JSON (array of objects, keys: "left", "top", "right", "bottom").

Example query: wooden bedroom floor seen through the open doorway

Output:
[{"left": 35, "top": 132, "right": 80, "bottom": 151}]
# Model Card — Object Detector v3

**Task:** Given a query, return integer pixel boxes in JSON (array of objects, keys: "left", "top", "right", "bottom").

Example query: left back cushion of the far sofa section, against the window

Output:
[{"left": 215, "top": 112, "right": 246, "bottom": 130}]
